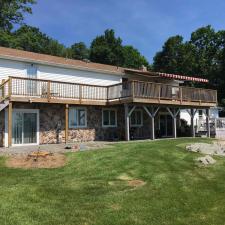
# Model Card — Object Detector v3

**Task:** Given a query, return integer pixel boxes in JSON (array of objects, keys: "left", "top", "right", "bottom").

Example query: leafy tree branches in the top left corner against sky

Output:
[{"left": 0, "top": 0, "right": 36, "bottom": 31}]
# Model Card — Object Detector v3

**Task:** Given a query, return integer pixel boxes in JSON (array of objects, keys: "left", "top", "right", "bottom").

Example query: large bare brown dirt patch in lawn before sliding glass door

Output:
[{"left": 6, "top": 153, "right": 66, "bottom": 169}]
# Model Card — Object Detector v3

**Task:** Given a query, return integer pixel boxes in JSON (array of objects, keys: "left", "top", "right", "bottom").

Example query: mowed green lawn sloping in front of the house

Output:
[{"left": 0, "top": 139, "right": 225, "bottom": 225}]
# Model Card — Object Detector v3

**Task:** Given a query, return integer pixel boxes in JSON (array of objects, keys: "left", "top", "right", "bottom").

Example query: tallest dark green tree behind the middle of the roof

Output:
[{"left": 90, "top": 30, "right": 124, "bottom": 66}]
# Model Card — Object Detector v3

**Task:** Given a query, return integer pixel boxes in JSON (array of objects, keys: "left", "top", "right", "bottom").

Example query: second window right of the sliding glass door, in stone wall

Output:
[{"left": 102, "top": 109, "right": 117, "bottom": 127}]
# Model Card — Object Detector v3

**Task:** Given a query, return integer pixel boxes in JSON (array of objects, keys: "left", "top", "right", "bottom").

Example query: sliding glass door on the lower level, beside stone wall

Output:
[{"left": 12, "top": 110, "right": 38, "bottom": 145}]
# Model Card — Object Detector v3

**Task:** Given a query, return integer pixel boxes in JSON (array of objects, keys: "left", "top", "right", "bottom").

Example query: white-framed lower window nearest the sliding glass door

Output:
[{"left": 69, "top": 107, "right": 87, "bottom": 128}]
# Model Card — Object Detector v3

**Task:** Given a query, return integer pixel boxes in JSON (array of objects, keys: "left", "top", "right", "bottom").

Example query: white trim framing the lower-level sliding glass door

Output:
[{"left": 4, "top": 109, "right": 40, "bottom": 147}]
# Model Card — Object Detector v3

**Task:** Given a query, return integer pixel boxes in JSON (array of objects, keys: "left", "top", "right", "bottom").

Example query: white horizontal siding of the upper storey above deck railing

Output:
[{"left": 0, "top": 59, "right": 122, "bottom": 86}]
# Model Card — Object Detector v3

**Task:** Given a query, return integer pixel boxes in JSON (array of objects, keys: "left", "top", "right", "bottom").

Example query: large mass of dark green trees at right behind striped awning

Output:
[{"left": 153, "top": 26, "right": 225, "bottom": 102}]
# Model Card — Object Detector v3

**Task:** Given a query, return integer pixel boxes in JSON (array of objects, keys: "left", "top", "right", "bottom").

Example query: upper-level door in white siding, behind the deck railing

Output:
[{"left": 26, "top": 64, "right": 37, "bottom": 96}]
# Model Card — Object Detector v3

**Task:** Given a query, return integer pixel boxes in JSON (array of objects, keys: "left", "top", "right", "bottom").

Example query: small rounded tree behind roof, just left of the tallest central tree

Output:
[{"left": 70, "top": 42, "right": 89, "bottom": 60}]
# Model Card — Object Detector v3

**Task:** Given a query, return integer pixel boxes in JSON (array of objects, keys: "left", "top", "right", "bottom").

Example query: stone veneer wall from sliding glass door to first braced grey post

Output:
[{"left": 13, "top": 103, "right": 124, "bottom": 144}]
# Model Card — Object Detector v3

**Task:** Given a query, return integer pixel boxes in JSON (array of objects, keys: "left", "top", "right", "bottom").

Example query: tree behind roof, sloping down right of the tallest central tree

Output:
[{"left": 123, "top": 46, "right": 149, "bottom": 69}]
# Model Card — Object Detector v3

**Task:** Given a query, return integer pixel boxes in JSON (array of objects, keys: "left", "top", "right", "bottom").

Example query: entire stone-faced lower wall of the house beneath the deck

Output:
[{"left": 5, "top": 103, "right": 181, "bottom": 145}]
